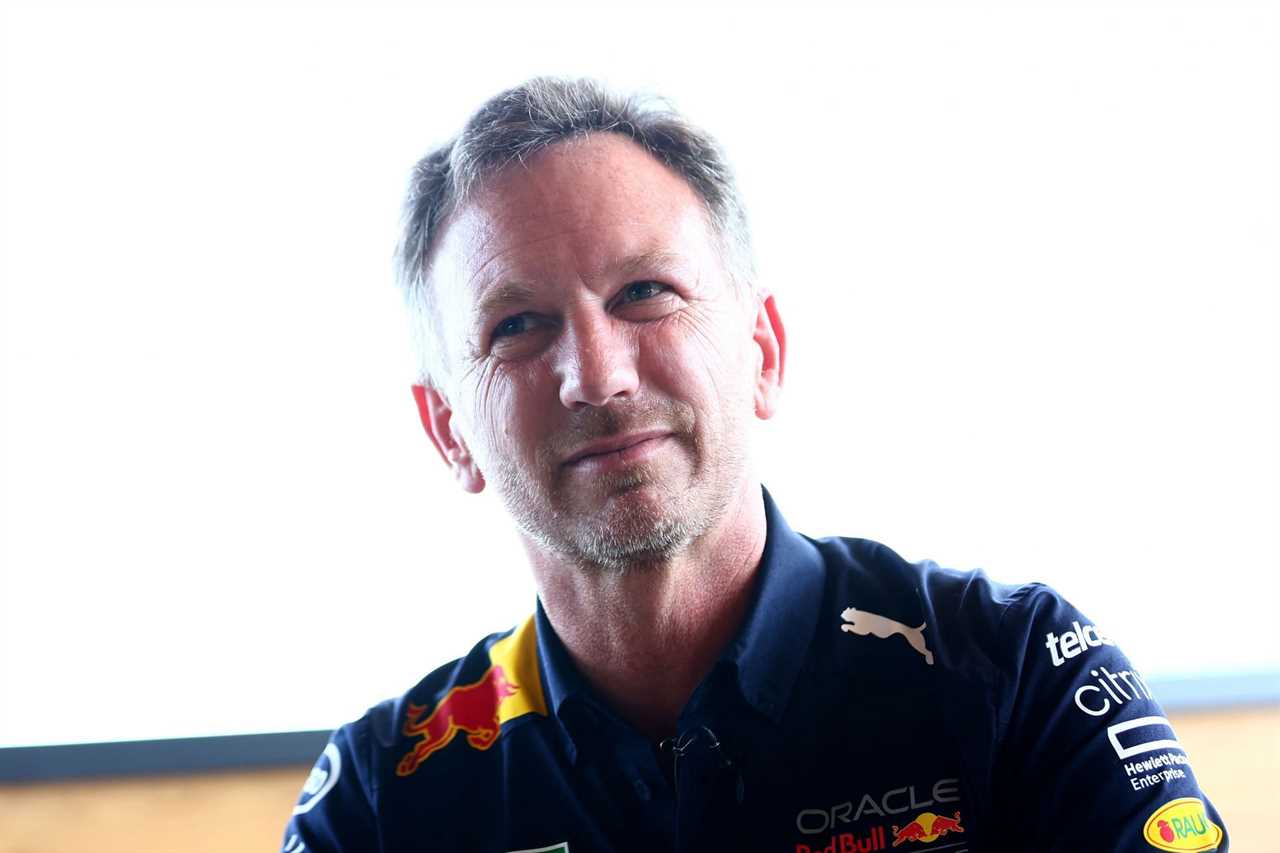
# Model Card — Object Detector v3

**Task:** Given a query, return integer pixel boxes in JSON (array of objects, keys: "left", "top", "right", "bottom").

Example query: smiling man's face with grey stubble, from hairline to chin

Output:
[{"left": 424, "top": 134, "right": 781, "bottom": 569}]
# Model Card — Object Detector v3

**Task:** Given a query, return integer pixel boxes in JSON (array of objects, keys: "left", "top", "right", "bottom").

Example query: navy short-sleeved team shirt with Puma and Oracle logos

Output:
[{"left": 283, "top": 493, "right": 1228, "bottom": 853}]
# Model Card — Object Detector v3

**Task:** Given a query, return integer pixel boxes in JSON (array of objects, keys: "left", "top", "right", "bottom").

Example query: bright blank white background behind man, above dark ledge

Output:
[{"left": 0, "top": 3, "right": 1280, "bottom": 745}]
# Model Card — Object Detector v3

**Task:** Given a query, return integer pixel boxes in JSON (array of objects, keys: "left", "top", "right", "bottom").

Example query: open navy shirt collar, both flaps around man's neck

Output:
[{"left": 535, "top": 488, "right": 826, "bottom": 757}]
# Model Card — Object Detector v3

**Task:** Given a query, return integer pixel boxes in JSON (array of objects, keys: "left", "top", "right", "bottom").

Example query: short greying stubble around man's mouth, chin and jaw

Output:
[{"left": 486, "top": 403, "right": 746, "bottom": 573}]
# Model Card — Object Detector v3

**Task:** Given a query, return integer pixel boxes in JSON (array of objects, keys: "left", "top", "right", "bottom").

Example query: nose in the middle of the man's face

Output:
[{"left": 556, "top": 316, "right": 640, "bottom": 409}]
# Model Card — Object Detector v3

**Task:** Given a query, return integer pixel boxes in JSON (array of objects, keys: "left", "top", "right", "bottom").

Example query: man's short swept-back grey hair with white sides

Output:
[{"left": 396, "top": 77, "right": 755, "bottom": 384}]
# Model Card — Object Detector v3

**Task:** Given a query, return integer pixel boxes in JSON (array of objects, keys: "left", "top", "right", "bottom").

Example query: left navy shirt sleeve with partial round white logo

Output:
[{"left": 280, "top": 724, "right": 381, "bottom": 853}]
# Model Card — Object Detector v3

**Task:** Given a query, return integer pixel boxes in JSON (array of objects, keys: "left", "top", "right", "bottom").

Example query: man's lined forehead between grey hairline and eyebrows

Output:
[{"left": 430, "top": 133, "right": 719, "bottom": 315}]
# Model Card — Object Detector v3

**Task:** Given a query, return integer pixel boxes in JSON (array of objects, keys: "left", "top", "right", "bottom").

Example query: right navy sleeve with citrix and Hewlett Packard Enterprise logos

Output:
[{"left": 992, "top": 584, "right": 1228, "bottom": 853}]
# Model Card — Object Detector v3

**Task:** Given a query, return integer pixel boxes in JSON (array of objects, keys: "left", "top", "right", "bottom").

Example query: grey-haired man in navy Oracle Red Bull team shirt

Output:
[{"left": 284, "top": 79, "right": 1226, "bottom": 853}]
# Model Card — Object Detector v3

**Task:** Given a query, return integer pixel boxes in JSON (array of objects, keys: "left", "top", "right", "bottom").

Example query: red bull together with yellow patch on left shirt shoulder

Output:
[{"left": 396, "top": 619, "right": 547, "bottom": 776}]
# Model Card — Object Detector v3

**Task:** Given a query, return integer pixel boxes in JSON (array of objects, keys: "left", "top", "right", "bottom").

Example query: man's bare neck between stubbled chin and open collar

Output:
[{"left": 530, "top": 482, "right": 765, "bottom": 739}]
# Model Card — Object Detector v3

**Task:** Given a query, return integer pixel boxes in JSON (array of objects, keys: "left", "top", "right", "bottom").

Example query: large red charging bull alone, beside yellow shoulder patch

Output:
[{"left": 396, "top": 666, "right": 520, "bottom": 776}]
